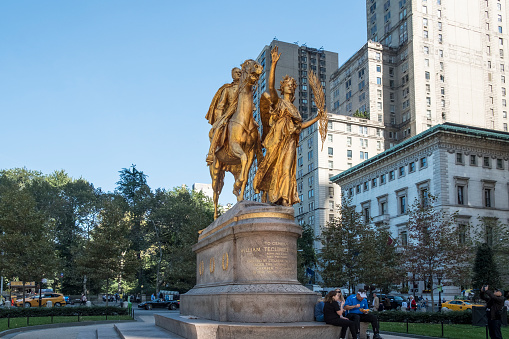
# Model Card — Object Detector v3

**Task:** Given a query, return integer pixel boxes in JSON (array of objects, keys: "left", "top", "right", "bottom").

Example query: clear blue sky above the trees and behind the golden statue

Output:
[{"left": 0, "top": 0, "right": 366, "bottom": 204}]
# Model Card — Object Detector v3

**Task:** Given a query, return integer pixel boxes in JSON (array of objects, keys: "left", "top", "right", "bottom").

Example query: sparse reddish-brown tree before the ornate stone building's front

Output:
[{"left": 404, "top": 195, "right": 470, "bottom": 305}]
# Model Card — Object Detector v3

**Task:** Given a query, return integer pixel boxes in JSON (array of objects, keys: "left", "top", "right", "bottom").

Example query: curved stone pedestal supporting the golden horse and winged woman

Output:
[{"left": 180, "top": 201, "right": 317, "bottom": 323}]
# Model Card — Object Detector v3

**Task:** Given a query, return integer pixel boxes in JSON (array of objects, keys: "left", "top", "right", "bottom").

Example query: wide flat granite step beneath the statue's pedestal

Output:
[{"left": 154, "top": 314, "right": 341, "bottom": 339}]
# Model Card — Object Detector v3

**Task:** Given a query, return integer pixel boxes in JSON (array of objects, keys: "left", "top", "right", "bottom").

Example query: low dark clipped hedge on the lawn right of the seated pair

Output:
[{"left": 373, "top": 311, "right": 472, "bottom": 324}]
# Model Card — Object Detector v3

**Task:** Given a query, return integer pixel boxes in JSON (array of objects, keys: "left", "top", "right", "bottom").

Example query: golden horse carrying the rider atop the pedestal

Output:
[{"left": 205, "top": 59, "right": 263, "bottom": 219}]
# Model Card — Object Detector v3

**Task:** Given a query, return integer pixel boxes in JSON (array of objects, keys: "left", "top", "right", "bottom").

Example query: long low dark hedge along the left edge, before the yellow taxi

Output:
[{"left": 0, "top": 306, "right": 129, "bottom": 318}]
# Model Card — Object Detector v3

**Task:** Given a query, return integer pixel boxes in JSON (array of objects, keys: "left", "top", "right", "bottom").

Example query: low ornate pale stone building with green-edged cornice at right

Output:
[{"left": 331, "top": 123, "right": 509, "bottom": 293}]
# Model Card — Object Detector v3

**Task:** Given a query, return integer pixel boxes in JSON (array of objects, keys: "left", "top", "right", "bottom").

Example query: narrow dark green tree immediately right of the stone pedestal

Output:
[{"left": 297, "top": 224, "right": 317, "bottom": 284}]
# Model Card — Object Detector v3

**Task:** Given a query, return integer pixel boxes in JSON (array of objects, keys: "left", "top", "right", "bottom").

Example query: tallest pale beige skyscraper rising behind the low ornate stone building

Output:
[{"left": 331, "top": 0, "right": 509, "bottom": 147}]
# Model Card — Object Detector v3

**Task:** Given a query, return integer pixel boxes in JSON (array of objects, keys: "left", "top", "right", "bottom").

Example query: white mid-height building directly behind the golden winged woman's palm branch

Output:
[{"left": 294, "top": 114, "right": 384, "bottom": 249}]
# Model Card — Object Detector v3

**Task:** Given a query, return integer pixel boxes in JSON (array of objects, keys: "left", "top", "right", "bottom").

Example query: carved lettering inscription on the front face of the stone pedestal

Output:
[{"left": 240, "top": 241, "right": 294, "bottom": 275}]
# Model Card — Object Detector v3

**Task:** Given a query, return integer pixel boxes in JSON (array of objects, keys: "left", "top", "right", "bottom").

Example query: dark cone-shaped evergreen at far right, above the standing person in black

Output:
[{"left": 472, "top": 243, "right": 500, "bottom": 289}]
